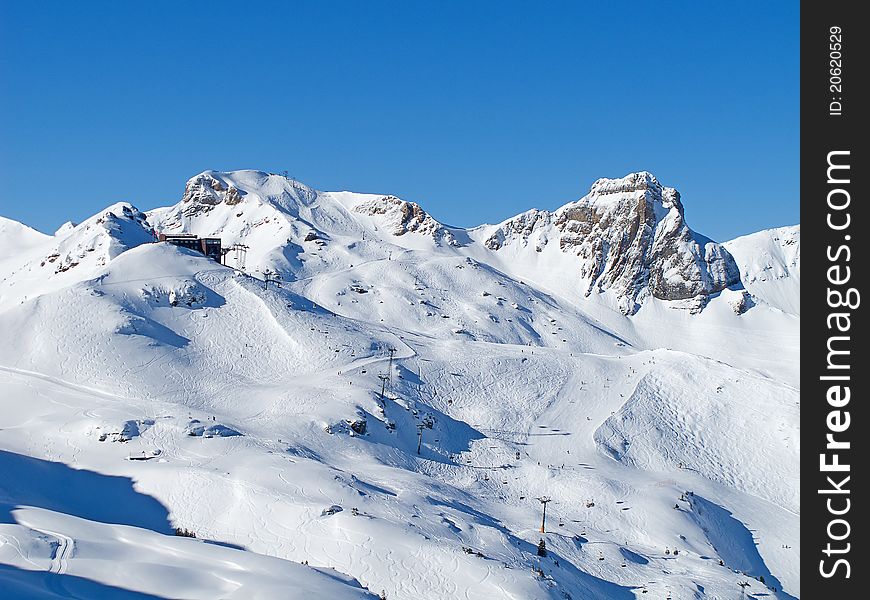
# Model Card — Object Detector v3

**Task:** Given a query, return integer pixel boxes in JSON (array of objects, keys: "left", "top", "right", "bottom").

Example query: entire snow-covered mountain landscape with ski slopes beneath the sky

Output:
[{"left": 0, "top": 171, "right": 800, "bottom": 600}]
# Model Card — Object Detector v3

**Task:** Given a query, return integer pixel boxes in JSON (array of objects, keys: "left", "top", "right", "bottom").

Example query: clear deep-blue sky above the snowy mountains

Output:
[{"left": 0, "top": 0, "right": 799, "bottom": 240}]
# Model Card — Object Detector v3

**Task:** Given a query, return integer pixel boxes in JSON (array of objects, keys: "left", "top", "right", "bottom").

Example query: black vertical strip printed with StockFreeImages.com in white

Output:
[{"left": 800, "top": 1, "right": 870, "bottom": 600}]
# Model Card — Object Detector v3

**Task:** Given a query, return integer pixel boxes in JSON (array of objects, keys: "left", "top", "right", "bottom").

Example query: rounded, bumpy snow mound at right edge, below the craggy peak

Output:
[{"left": 595, "top": 356, "right": 800, "bottom": 512}]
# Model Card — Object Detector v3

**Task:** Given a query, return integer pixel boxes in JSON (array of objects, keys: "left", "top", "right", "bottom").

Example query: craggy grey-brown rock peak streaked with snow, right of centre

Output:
[{"left": 484, "top": 172, "right": 740, "bottom": 314}]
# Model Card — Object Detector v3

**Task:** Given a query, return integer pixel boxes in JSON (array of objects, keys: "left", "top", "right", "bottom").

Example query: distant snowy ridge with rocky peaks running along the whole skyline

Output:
[{"left": 1, "top": 170, "right": 800, "bottom": 324}]
